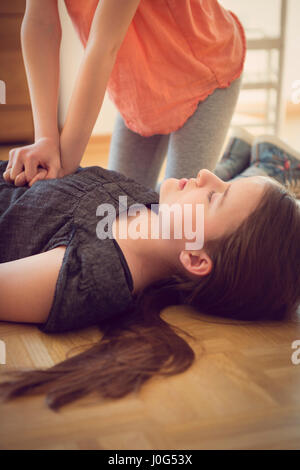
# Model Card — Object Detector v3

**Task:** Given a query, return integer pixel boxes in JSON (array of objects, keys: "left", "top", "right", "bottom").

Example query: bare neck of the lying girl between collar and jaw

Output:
[{"left": 112, "top": 209, "right": 174, "bottom": 294}]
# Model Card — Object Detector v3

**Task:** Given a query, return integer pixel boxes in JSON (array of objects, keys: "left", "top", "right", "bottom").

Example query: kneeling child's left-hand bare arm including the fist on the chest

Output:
[{"left": 3, "top": 0, "right": 62, "bottom": 186}]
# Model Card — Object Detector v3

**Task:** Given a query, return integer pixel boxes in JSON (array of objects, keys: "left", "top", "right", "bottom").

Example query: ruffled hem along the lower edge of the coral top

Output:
[{"left": 118, "top": 10, "right": 247, "bottom": 137}]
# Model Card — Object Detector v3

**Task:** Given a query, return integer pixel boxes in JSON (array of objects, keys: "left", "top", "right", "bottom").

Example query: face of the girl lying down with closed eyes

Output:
[{"left": 159, "top": 169, "right": 272, "bottom": 243}]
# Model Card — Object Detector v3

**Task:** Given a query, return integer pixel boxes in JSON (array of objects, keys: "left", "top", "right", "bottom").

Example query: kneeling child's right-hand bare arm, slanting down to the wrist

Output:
[{"left": 60, "top": 0, "right": 140, "bottom": 174}]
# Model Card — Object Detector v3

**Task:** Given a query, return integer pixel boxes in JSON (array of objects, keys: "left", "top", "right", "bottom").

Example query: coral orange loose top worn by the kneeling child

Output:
[{"left": 65, "top": 0, "right": 246, "bottom": 137}]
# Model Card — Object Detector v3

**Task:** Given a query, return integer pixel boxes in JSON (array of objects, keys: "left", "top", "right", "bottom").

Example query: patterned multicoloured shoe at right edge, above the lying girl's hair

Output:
[{"left": 250, "top": 135, "right": 300, "bottom": 198}]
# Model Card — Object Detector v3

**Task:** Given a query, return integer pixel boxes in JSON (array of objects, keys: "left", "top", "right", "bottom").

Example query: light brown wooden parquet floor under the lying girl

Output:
[{"left": 0, "top": 140, "right": 300, "bottom": 450}]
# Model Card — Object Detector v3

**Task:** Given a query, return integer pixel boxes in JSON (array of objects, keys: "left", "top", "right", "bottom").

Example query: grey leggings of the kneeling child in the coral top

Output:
[{"left": 108, "top": 77, "right": 241, "bottom": 192}]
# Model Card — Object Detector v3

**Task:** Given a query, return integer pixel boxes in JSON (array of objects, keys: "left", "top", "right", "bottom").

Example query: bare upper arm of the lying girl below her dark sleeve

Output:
[{"left": 0, "top": 246, "right": 66, "bottom": 323}]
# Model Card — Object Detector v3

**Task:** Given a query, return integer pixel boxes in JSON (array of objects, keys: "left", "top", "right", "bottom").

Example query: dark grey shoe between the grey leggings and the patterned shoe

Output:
[{"left": 213, "top": 127, "right": 254, "bottom": 181}]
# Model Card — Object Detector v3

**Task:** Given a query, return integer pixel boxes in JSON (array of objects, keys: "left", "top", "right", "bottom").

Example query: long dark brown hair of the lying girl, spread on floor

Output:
[{"left": 0, "top": 183, "right": 300, "bottom": 410}]
